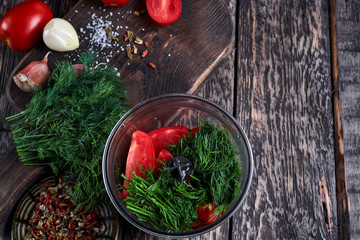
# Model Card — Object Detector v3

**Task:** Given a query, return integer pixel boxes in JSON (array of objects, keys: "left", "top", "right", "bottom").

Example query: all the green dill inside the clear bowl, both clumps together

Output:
[{"left": 122, "top": 121, "right": 241, "bottom": 232}]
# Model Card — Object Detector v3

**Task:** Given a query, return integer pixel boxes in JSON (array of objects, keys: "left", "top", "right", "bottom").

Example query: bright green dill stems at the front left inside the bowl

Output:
[{"left": 122, "top": 168, "right": 206, "bottom": 232}]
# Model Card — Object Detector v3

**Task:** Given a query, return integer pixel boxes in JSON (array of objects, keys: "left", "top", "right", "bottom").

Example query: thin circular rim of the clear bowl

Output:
[{"left": 102, "top": 93, "right": 254, "bottom": 238}]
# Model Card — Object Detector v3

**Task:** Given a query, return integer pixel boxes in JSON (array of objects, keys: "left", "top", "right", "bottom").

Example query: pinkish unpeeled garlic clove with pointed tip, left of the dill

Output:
[{"left": 13, "top": 52, "right": 50, "bottom": 92}]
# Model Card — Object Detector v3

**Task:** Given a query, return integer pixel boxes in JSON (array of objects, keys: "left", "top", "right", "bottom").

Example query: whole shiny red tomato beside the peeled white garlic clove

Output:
[{"left": 0, "top": 0, "right": 53, "bottom": 52}]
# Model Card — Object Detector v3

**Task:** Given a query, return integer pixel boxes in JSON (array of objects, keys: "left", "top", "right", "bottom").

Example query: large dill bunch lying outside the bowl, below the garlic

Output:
[{"left": 7, "top": 52, "right": 130, "bottom": 210}]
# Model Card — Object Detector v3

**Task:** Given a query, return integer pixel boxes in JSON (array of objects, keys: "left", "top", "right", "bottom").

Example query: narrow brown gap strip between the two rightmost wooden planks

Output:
[{"left": 329, "top": 0, "right": 350, "bottom": 240}]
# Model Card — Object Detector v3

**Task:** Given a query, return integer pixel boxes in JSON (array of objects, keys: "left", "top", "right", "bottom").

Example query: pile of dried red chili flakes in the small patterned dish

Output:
[{"left": 26, "top": 178, "right": 105, "bottom": 240}]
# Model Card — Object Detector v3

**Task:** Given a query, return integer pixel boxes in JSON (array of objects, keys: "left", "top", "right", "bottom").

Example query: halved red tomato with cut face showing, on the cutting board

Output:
[{"left": 146, "top": 0, "right": 182, "bottom": 25}]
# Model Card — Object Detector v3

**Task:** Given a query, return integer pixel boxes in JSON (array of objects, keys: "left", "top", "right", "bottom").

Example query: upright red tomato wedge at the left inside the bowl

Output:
[{"left": 124, "top": 130, "right": 156, "bottom": 197}]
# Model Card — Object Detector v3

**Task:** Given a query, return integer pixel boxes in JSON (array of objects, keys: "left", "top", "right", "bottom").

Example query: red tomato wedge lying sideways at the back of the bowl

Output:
[{"left": 148, "top": 126, "right": 189, "bottom": 154}]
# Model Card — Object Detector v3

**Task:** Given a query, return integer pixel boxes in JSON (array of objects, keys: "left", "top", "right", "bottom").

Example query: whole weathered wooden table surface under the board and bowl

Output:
[{"left": 0, "top": 0, "right": 360, "bottom": 239}]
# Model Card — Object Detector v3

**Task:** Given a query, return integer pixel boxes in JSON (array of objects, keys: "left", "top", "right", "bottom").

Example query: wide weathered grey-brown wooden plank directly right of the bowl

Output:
[{"left": 233, "top": 0, "right": 337, "bottom": 239}]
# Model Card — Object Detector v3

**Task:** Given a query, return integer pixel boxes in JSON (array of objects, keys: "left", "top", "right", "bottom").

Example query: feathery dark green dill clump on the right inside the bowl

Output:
[{"left": 169, "top": 120, "right": 241, "bottom": 215}]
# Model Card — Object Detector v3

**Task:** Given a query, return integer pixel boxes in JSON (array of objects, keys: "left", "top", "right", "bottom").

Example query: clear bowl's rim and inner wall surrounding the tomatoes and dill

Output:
[{"left": 102, "top": 94, "right": 253, "bottom": 238}]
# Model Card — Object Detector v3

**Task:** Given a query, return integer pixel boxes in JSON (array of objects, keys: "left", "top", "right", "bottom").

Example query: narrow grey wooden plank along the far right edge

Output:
[{"left": 335, "top": 0, "right": 360, "bottom": 239}]
